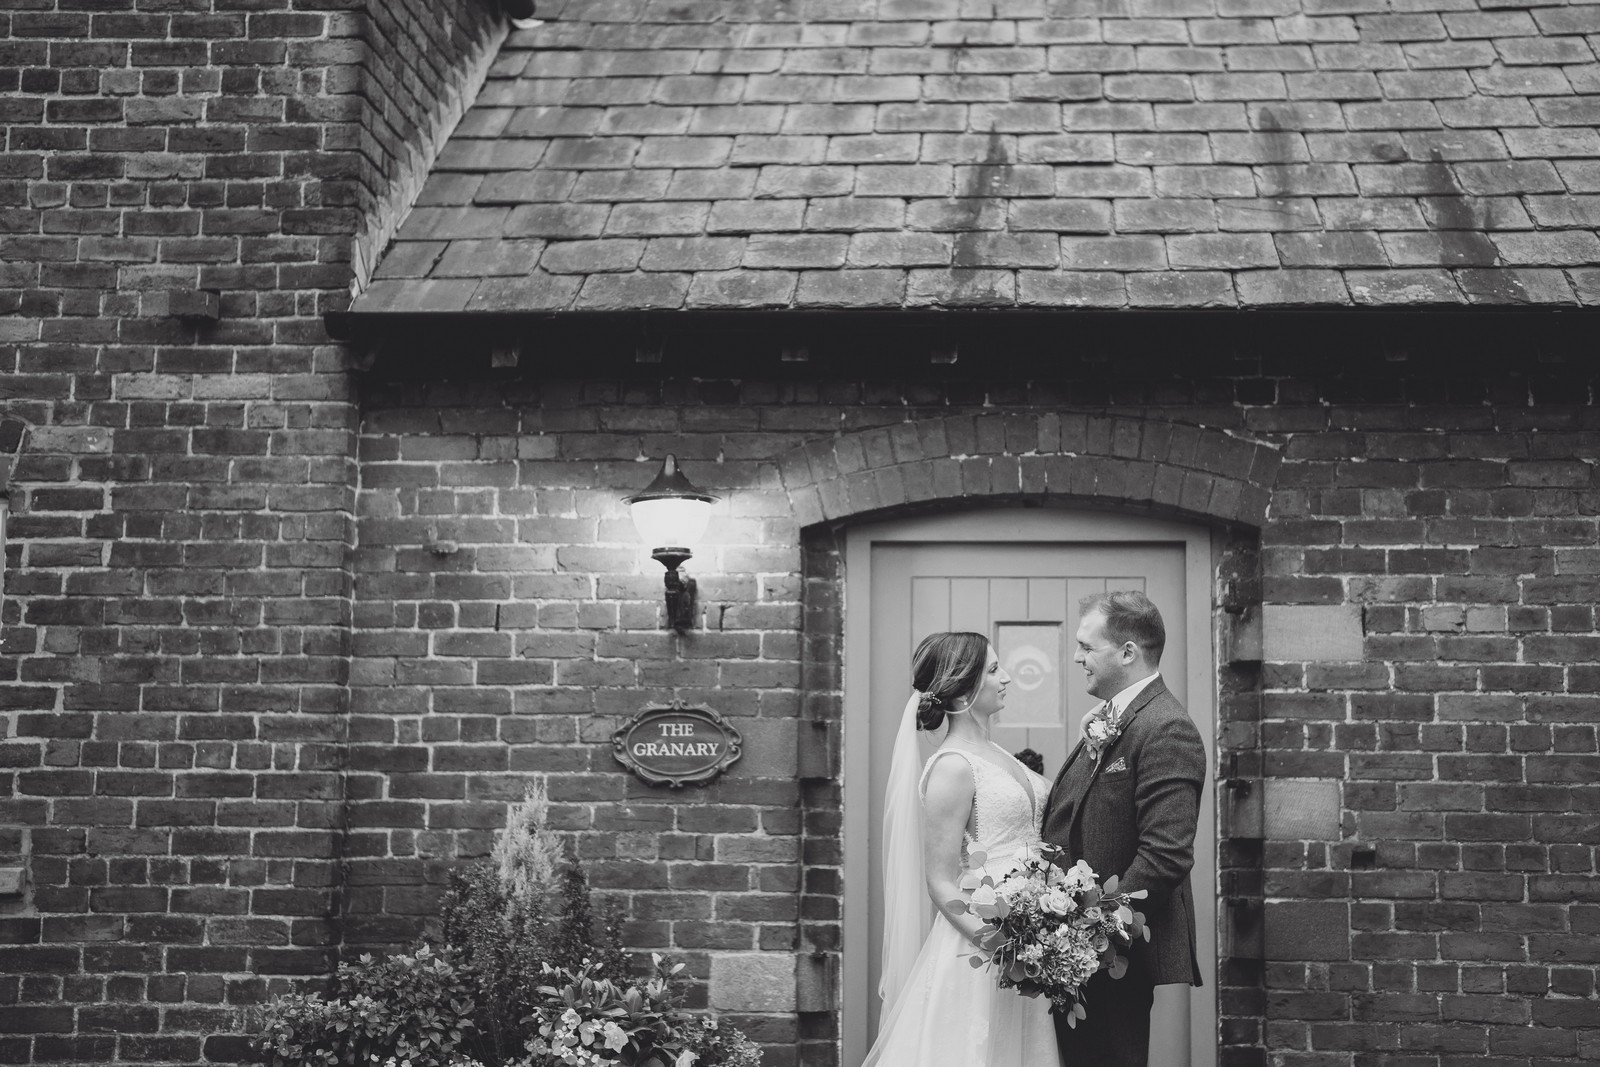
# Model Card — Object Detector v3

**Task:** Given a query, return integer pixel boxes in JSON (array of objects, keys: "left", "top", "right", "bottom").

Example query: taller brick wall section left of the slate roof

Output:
[{"left": 0, "top": 0, "right": 496, "bottom": 1062}]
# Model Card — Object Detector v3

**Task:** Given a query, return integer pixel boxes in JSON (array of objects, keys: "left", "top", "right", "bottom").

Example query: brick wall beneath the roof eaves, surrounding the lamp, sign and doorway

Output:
[{"left": 350, "top": 331, "right": 1600, "bottom": 1067}]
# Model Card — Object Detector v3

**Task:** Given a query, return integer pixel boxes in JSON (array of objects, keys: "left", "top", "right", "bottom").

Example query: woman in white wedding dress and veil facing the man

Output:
[{"left": 862, "top": 633, "right": 1059, "bottom": 1067}]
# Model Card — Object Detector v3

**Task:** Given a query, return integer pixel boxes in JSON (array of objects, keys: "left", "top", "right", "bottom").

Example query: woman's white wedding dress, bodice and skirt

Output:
[{"left": 862, "top": 741, "right": 1059, "bottom": 1067}]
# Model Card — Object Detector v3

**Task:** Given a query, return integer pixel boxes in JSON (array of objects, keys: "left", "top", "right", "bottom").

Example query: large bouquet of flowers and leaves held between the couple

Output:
[{"left": 950, "top": 845, "right": 1150, "bottom": 1025}]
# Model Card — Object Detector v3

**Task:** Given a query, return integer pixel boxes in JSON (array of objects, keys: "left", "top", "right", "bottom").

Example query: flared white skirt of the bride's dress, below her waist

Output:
[{"left": 862, "top": 915, "right": 1061, "bottom": 1067}]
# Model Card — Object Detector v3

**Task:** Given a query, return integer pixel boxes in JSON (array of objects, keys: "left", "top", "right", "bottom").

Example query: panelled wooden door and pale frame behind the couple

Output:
[{"left": 845, "top": 510, "right": 1214, "bottom": 1067}]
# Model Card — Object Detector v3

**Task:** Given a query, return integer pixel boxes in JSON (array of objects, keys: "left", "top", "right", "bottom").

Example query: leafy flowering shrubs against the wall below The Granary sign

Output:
[{"left": 256, "top": 784, "right": 760, "bottom": 1067}]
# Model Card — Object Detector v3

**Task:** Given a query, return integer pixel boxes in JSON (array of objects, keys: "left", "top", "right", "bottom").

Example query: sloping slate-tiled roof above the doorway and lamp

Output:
[{"left": 352, "top": 0, "right": 1600, "bottom": 315}]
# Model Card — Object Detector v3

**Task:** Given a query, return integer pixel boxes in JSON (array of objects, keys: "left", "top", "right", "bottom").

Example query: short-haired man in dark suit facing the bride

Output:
[{"left": 1043, "top": 592, "right": 1206, "bottom": 1067}]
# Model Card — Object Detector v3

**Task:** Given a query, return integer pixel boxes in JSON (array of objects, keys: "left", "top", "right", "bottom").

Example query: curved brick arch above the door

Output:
[{"left": 779, "top": 413, "right": 1282, "bottom": 528}]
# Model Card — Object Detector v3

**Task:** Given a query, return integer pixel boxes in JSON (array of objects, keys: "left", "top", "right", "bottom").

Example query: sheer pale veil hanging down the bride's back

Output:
[{"left": 878, "top": 689, "right": 933, "bottom": 1009}]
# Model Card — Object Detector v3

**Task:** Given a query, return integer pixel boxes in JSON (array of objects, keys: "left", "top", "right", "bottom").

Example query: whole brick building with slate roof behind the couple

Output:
[{"left": 0, "top": 0, "right": 1600, "bottom": 1067}]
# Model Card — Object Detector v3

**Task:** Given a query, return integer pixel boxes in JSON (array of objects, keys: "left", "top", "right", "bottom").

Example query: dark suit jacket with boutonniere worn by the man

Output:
[{"left": 1043, "top": 678, "right": 1206, "bottom": 985}]
